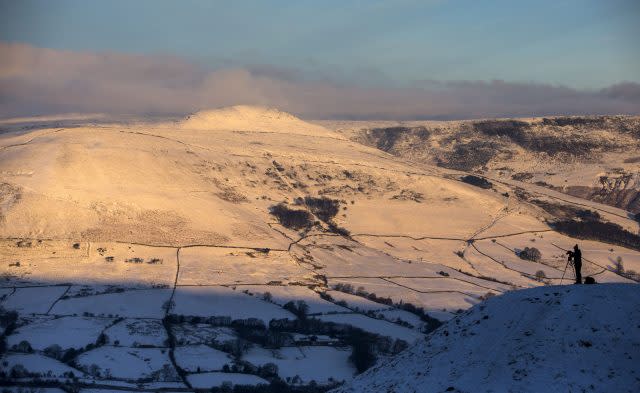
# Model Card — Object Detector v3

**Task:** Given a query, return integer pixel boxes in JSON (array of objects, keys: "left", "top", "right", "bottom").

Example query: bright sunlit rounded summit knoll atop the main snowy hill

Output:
[{"left": 181, "top": 105, "right": 344, "bottom": 139}]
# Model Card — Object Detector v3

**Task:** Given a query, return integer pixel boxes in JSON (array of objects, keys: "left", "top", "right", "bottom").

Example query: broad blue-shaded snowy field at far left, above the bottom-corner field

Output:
[{"left": 7, "top": 317, "right": 112, "bottom": 350}]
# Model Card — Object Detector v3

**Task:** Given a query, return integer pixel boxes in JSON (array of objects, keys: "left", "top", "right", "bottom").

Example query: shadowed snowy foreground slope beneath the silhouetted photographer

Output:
[{"left": 335, "top": 284, "right": 640, "bottom": 393}]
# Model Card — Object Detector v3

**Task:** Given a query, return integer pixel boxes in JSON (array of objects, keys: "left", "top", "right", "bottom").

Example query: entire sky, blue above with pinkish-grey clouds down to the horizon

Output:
[{"left": 0, "top": 0, "right": 640, "bottom": 119}]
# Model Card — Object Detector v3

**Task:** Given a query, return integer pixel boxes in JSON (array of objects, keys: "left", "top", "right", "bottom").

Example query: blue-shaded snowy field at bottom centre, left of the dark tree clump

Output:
[{"left": 243, "top": 346, "right": 355, "bottom": 383}]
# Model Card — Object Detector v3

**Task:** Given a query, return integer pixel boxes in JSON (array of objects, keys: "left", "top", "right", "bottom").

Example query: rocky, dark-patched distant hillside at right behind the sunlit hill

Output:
[{"left": 355, "top": 116, "right": 640, "bottom": 213}]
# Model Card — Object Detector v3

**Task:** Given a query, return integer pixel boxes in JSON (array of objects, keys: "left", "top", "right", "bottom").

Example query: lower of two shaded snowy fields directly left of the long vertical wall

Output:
[{"left": 77, "top": 346, "right": 175, "bottom": 380}]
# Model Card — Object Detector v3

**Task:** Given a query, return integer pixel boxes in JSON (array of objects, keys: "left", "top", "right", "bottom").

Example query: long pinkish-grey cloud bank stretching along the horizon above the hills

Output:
[{"left": 0, "top": 42, "right": 640, "bottom": 119}]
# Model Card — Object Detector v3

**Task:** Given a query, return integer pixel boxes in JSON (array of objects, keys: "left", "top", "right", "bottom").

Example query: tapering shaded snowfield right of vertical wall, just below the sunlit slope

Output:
[{"left": 172, "top": 286, "right": 295, "bottom": 326}]
